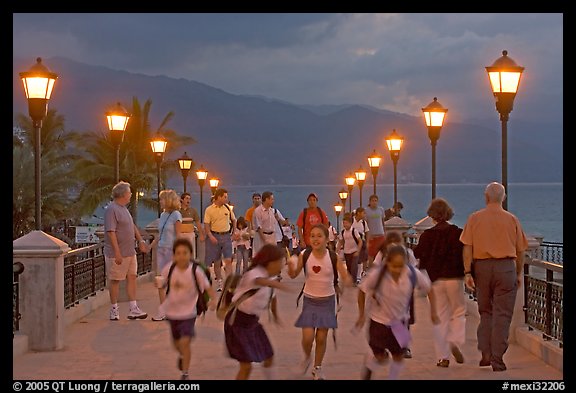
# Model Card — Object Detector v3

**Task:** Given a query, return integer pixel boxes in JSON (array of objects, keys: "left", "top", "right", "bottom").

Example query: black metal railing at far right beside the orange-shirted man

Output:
[{"left": 524, "top": 257, "right": 564, "bottom": 348}]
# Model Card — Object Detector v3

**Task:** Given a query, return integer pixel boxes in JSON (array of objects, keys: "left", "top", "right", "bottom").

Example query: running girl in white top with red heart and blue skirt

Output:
[{"left": 288, "top": 224, "right": 353, "bottom": 380}]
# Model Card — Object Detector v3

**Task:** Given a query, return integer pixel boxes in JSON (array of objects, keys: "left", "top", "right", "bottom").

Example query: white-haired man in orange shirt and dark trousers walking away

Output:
[{"left": 460, "top": 182, "right": 528, "bottom": 371}]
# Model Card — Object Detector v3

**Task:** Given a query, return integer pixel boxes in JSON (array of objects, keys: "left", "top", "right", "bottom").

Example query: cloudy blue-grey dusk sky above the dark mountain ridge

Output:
[{"left": 13, "top": 13, "right": 563, "bottom": 123}]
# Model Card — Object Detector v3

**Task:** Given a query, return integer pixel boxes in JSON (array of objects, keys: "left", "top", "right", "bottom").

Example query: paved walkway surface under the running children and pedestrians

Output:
[{"left": 13, "top": 266, "right": 563, "bottom": 380}]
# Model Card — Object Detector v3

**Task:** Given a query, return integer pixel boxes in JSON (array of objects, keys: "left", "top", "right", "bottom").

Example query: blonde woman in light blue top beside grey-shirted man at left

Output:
[{"left": 151, "top": 190, "right": 182, "bottom": 321}]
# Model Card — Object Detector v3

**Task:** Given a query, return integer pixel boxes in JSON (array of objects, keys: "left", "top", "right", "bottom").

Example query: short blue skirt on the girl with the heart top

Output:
[{"left": 294, "top": 295, "right": 338, "bottom": 329}]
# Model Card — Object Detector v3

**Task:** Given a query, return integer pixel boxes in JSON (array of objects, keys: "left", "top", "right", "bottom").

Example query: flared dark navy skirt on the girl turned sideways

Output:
[{"left": 224, "top": 310, "right": 274, "bottom": 363}]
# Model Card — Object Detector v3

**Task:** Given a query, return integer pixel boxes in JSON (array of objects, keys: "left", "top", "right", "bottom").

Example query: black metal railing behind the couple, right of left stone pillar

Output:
[{"left": 64, "top": 237, "right": 152, "bottom": 308}]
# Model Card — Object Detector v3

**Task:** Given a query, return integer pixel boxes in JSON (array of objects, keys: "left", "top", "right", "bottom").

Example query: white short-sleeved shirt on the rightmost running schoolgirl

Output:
[{"left": 358, "top": 265, "right": 432, "bottom": 325}]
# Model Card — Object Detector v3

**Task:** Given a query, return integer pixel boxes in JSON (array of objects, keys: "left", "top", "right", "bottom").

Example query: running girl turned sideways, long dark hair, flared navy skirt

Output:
[{"left": 224, "top": 244, "right": 290, "bottom": 379}]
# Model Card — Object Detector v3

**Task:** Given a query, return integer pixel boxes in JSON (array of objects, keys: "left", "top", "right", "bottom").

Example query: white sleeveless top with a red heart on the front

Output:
[{"left": 301, "top": 249, "right": 336, "bottom": 297}]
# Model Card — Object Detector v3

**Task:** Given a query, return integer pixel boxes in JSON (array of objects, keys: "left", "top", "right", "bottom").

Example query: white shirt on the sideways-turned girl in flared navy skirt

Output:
[{"left": 232, "top": 266, "right": 272, "bottom": 316}]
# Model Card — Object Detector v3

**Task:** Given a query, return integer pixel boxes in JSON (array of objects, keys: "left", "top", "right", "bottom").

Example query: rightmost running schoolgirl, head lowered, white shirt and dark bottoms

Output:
[{"left": 356, "top": 243, "right": 431, "bottom": 379}]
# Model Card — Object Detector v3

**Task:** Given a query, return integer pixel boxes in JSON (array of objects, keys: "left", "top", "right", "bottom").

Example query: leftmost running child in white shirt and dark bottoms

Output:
[{"left": 156, "top": 238, "right": 216, "bottom": 379}]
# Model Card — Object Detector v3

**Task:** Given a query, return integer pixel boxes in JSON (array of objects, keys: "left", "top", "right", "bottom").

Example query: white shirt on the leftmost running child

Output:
[{"left": 161, "top": 263, "right": 210, "bottom": 320}]
